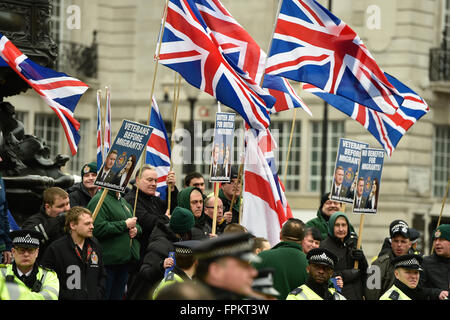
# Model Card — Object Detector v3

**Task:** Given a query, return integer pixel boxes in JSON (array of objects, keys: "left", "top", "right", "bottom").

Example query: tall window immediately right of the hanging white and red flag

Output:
[{"left": 270, "top": 121, "right": 301, "bottom": 191}]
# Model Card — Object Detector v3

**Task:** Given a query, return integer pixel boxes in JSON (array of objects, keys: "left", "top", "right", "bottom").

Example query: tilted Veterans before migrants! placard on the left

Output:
[{"left": 94, "top": 120, "right": 153, "bottom": 192}]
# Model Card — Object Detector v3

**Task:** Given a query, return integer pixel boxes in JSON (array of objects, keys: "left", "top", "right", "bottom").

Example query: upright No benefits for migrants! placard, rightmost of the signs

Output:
[{"left": 353, "top": 148, "right": 385, "bottom": 214}]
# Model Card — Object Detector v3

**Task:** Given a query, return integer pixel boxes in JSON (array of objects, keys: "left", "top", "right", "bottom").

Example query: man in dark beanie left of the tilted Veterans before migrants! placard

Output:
[{"left": 67, "top": 162, "right": 98, "bottom": 208}]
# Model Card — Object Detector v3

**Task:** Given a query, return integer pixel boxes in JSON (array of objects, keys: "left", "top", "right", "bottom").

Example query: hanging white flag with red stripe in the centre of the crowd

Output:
[{"left": 241, "top": 130, "right": 292, "bottom": 246}]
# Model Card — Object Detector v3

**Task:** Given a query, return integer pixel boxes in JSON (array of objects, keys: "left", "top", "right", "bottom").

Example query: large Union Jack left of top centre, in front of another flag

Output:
[{"left": 159, "top": 0, "right": 275, "bottom": 129}]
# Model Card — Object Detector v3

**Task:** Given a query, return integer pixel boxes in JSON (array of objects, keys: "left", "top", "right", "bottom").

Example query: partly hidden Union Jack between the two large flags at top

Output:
[{"left": 194, "top": 0, "right": 311, "bottom": 115}]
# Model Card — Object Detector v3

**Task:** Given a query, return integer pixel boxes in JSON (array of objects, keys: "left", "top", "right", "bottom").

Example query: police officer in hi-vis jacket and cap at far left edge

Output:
[{"left": 0, "top": 230, "right": 59, "bottom": 300}]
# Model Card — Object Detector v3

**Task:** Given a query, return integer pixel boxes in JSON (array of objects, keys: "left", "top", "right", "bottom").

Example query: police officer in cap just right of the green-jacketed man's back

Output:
[{"left": 286, "top": 248, "right": 346, "bottom": 300}]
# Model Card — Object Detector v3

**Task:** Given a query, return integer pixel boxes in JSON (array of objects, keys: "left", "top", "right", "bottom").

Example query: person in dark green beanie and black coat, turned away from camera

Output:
[{"left": 127, "top": 207, "right": 195, "bottom": 300}]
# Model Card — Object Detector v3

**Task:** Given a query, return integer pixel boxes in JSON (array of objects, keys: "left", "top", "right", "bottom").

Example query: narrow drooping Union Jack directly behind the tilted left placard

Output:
[{"left": 145, "top": 97, "right": 170, "bottom": 200}]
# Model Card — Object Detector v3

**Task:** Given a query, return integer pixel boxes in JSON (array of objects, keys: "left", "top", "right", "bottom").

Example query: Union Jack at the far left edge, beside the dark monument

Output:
[{"left": 0, "top": 33, "right": 89, "bottom": 155}]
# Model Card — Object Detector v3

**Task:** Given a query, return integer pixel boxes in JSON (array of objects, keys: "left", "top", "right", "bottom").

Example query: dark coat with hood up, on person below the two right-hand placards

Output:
[{"left": 320, "top": 212, "right": 368, "bottom": 300}]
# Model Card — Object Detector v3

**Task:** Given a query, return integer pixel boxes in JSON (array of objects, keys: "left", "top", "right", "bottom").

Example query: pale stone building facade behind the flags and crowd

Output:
[{"left": 4, "top": 0, "right": 450, "bottom": 257}]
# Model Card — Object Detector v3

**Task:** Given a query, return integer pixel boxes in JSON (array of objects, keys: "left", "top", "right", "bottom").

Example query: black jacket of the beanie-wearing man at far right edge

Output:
[{"left": 419, "top": 253, "right": 450, "bottom": 300}]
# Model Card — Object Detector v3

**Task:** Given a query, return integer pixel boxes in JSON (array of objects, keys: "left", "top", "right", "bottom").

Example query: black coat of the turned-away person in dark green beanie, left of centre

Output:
[{"left": 127, "top": 222, "right": 180, "bottom": 300}]
